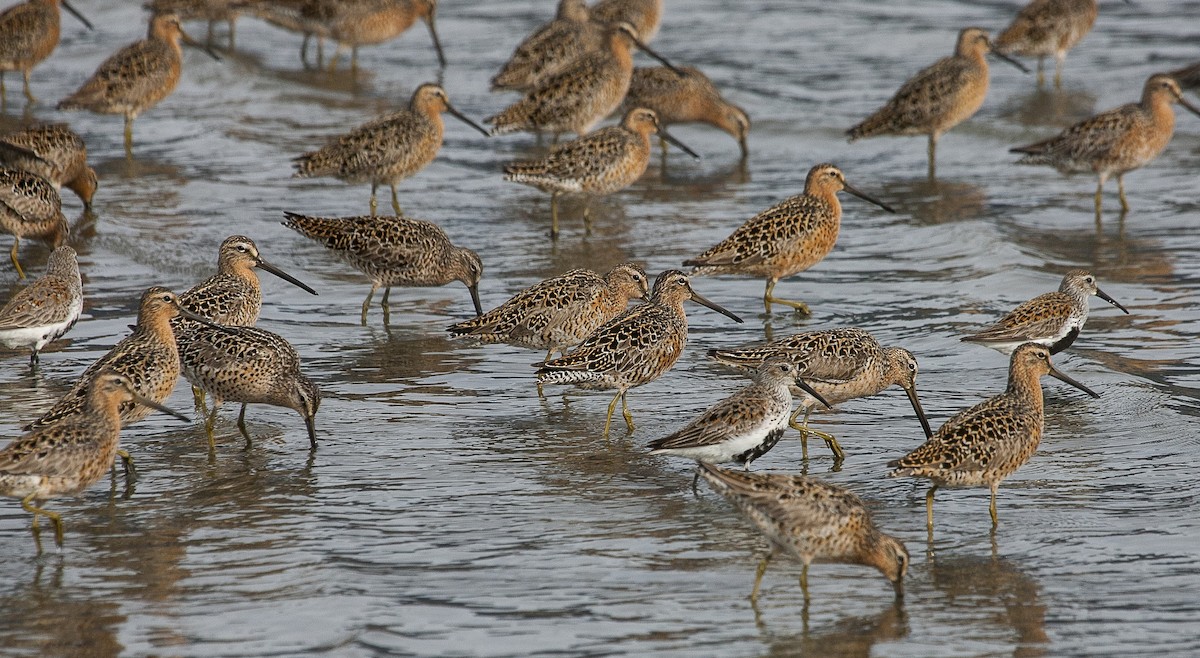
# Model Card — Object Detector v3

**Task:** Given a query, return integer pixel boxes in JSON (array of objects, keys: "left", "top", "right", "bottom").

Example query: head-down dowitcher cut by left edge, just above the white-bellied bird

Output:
[{"left": 0, "top": 168, "right": 71, "bottom": 279}]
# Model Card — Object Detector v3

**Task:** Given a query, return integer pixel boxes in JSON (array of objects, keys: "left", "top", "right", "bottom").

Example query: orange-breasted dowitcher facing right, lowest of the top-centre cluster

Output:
[{"left": 504, "top": 108, "right": 700, "bottom": 238}]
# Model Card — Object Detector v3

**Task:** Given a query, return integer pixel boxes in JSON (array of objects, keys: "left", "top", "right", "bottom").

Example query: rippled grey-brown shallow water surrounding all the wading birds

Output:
[{"left": 0, "top": 0, "right": 1200, "bottom": 656}]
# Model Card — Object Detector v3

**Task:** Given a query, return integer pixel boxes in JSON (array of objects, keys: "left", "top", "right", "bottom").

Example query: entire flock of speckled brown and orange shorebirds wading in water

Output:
[{"left": 0, "top": 0, "right": 1200, "bottom": 607}]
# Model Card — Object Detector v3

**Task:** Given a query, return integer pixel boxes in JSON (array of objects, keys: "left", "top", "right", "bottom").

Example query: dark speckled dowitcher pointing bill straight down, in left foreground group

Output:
[{"left": 179, "top": 325, "right": 320, "bottom": 450}]
